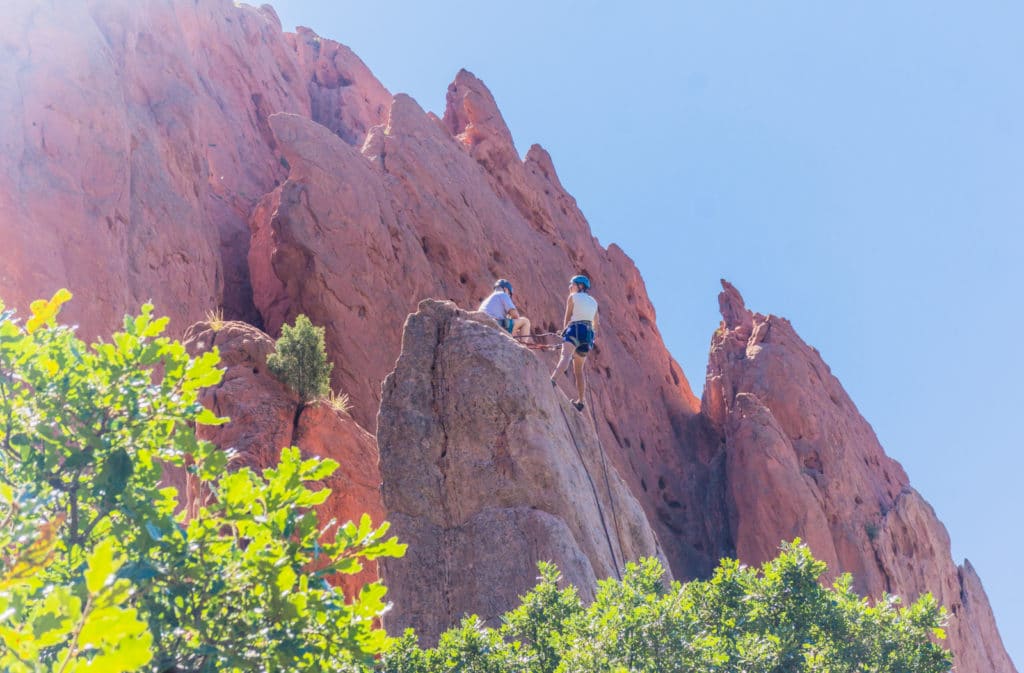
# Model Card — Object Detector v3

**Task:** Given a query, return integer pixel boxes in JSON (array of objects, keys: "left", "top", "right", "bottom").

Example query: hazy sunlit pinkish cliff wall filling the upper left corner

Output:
[{"left": 0, "top": 0, "right": 390, "bottom": 337}]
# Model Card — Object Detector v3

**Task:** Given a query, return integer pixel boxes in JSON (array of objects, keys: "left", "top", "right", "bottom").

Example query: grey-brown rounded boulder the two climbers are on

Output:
[{"left": 377, "top": 300, "right": 664, "bottom": 641}]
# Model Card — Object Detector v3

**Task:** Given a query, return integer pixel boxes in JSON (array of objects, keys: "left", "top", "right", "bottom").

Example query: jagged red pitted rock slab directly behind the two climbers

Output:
[{"left": 249, "top": 83, "right": 726, "bottom": 574}]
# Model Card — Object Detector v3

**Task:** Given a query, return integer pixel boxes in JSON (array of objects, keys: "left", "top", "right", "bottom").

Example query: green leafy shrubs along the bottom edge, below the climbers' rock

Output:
[{"left": 380, "top": 541, "right": 950, "bottom": 673}]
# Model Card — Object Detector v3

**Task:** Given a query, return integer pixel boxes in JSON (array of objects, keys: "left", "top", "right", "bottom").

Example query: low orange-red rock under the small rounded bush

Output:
[{"left": 175, "top": 322, "right": 384, "bottom": 591}]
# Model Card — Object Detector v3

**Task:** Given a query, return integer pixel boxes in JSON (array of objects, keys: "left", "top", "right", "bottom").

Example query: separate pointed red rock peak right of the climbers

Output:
[{"left": 702, "top": 281, "right": 1016, "bottom": 673}]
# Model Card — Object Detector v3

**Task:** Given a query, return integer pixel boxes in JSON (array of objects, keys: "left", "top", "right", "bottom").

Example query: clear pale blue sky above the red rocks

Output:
[{"left": 272, "top": 0, "right": 1024, "bottom": 666}]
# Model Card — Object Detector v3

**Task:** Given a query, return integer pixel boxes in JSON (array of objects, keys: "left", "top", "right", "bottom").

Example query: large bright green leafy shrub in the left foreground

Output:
[{"left": 0, "top": 291, "right": 404, "bottom": 673}]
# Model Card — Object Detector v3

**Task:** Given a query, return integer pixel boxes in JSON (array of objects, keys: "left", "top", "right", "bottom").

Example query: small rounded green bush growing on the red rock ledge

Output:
[{"left": 266, "top": 313, "right": 334, "bottom": 404}]
